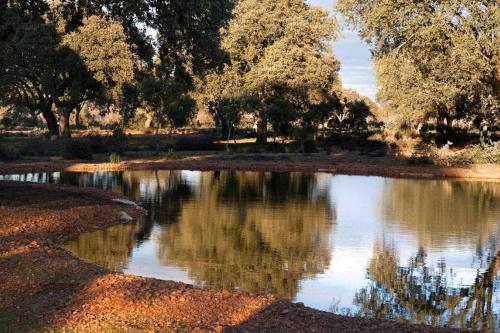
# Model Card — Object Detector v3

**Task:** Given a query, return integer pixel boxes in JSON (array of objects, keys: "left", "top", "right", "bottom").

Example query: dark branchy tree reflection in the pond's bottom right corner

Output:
[{"left": 355, "top": 241, "right": 500, "bottom": 331}]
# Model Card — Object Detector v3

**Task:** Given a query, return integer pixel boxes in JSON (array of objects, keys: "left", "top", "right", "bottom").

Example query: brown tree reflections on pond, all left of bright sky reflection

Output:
[{"left": 66, "top": 171, "right": 334, "bottom": 298}]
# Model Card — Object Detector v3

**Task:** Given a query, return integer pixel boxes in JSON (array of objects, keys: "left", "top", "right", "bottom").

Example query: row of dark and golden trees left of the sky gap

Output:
[{"left": 0, "top": 0, "right": 373, "bottom": 142}]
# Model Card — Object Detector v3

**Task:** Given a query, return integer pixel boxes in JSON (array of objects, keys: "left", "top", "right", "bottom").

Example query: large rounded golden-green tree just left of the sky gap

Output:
[{"left": 207, "top": 0, "right": 339, "bottom": 142}]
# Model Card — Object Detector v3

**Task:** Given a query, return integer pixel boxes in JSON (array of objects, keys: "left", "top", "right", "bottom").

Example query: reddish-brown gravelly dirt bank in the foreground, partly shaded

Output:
[{"left": 0, "top": 182, "right": 458, "bottom": 332}]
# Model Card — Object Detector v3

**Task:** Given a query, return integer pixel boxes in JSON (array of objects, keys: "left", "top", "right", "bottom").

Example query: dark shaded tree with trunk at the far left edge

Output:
[{"left": 0, "top": 6, "right": 95, "bottom": 136}]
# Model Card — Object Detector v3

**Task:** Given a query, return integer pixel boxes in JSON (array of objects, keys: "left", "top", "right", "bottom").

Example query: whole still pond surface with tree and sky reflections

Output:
[{"left": 0, "top": 171, "right": 500, "bottom": 330}]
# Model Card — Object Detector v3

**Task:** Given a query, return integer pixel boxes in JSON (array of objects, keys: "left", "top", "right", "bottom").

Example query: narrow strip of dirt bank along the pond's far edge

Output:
[{"left": 0, "top": 152, "right": 500, "bottom": 181}]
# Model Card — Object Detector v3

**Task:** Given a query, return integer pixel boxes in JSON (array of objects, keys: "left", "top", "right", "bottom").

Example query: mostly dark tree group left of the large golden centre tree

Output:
[{"left": 0, "top": 0, "right": 232, "bottom": 137}]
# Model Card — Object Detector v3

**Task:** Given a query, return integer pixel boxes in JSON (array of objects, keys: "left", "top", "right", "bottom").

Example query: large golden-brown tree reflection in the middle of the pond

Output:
[{"left": 158, "top": 172, "right": 332, "bottom": 298}]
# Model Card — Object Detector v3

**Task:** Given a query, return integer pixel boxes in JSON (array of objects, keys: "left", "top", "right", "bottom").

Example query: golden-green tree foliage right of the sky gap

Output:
[{"left": 337, "top": 0, "right": 500, "bottom": 131}]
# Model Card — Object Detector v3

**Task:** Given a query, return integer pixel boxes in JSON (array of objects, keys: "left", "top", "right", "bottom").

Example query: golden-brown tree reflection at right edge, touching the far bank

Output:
[{"left": 382, "top": 179, "right": 500, "bottom": 251}]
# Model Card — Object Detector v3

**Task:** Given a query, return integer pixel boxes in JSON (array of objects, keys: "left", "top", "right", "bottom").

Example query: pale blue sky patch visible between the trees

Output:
[{"left": 309, "top": 0, "right": 377, "bottom": 100}]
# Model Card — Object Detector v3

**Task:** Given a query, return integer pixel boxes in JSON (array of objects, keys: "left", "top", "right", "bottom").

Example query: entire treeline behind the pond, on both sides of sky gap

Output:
[{"left": 0, "top": 0, "right": 500, "bottom": 143}]
